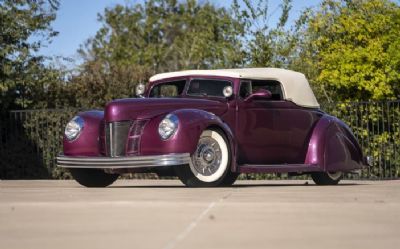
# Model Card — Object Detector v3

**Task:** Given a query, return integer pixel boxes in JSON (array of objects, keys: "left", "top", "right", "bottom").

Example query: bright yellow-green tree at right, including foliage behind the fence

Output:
[{"left": 290, "top": 0, "right": 400, "bottom": 179}]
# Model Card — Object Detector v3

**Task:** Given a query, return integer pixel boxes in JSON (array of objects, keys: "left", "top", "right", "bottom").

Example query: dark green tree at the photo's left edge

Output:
[{"left": 0, "top": 0, "right": 65, "bottom": 112}]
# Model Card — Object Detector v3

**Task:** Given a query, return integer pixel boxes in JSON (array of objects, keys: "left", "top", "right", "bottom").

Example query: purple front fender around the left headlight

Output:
[{"left": 63, "top": 110, "right": 104, "bottom": 156}]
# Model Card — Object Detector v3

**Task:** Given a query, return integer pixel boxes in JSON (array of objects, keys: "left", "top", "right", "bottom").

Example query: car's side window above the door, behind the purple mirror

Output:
[{"left": 240, "top": 80, "right": 283, "bottom": 100}]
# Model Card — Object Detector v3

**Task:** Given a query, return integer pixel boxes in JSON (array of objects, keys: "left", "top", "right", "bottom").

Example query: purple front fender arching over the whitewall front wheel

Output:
[{"left": 140, "top": 109, "right": 234, "bottom": 160}]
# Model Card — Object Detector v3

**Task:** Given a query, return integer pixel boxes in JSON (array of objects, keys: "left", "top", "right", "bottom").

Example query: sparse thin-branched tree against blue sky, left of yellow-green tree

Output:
[{"left": 232, "top": 0, "right": 295, "bottom": 67}]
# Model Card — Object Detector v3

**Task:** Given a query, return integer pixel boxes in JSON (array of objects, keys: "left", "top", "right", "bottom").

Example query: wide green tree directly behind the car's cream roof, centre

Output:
[{"left": 81, "top": 0, "right": 243, "bottom": 73}]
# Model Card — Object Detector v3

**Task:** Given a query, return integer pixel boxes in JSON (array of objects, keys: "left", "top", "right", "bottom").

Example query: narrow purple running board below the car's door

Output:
[{"left": 239, "top": 164, "right": 321, "bottom": 173}]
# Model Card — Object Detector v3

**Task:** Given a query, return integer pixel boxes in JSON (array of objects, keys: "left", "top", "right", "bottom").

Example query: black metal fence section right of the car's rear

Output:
[{"left": 324, "top": 100, "right": 400, "bottom": 179}]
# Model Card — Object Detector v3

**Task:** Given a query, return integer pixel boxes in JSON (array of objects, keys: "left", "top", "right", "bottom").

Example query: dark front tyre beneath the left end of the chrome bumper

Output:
[{"left": 69, "top": 168, "right": 119, "bottom": 188}]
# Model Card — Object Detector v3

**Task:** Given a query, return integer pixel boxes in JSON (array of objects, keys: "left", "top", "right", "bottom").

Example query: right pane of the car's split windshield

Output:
[{"left": 187, "top": 79, "right": 231, "bottom": 97}]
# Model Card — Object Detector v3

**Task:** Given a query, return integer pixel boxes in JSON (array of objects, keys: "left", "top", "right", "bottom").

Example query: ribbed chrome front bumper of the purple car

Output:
[{"left": 57, "top": 153, "right": 190, "bottom": 169}]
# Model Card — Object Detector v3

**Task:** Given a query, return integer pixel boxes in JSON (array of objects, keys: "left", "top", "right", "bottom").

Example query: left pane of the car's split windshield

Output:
[{"left": 149, "top": 80, "right": 186, "bottom": 98}]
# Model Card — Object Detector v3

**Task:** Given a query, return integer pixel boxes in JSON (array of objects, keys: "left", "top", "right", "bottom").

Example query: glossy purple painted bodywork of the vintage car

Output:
[{"left": 64, "top": 76, "right": 363, "bottom": 172}]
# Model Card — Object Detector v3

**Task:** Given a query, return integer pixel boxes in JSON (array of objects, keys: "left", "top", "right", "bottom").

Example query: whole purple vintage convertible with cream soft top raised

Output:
[{"left": 57, "top": 68, "right": 367, "bottom": 187}]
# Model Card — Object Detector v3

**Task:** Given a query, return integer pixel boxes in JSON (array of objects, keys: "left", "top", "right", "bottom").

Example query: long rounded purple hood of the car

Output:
[{"left": 104, "top": 98, "right": 227, "bottom": 122}]
